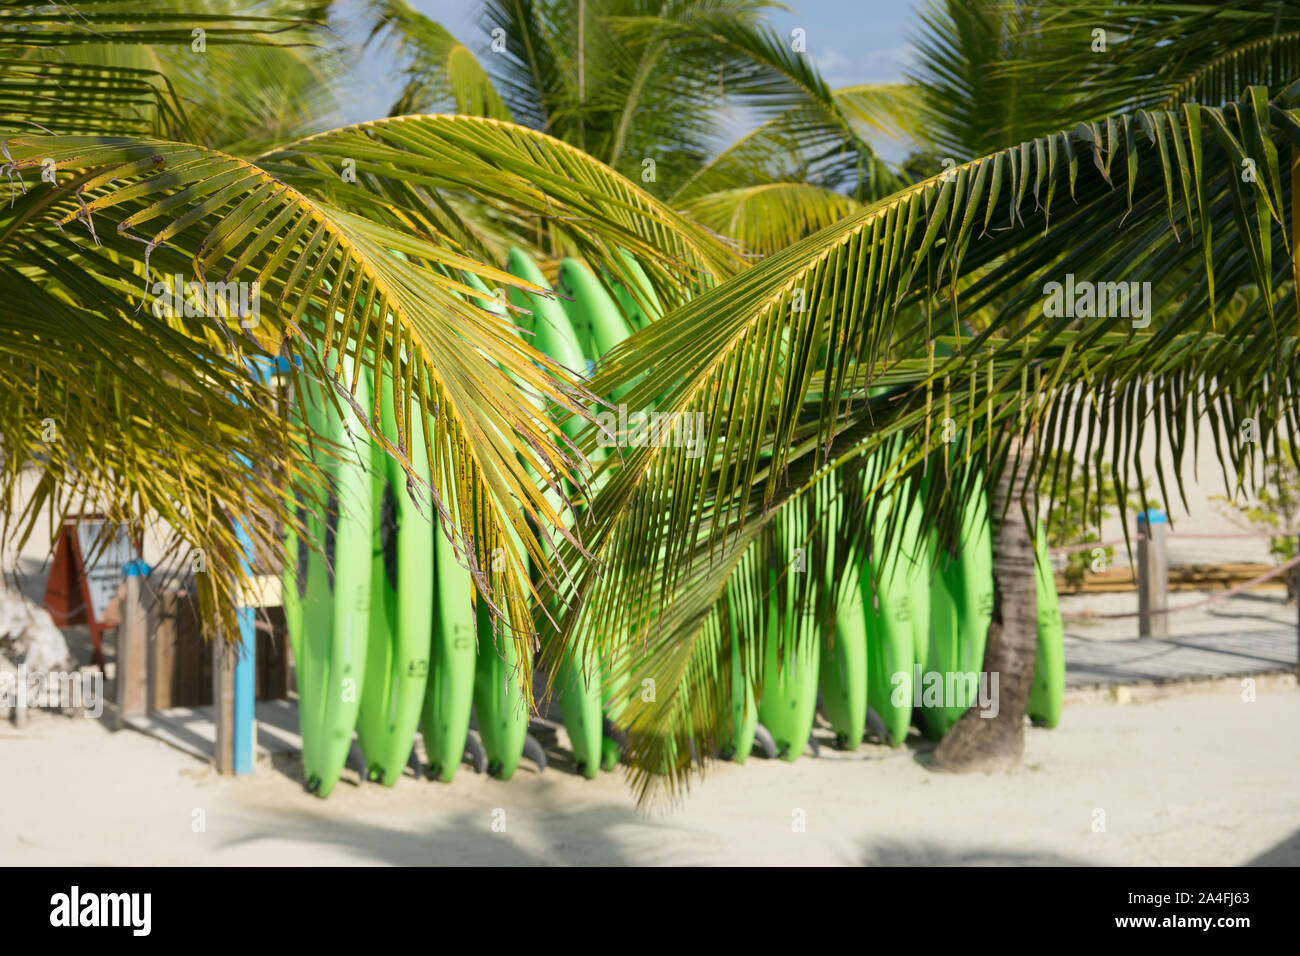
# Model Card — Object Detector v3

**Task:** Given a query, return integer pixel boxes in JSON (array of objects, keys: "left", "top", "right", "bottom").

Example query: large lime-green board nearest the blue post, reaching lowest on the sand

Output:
[{"left": 294, "top": 359, "right": 373, "bottom": 797}]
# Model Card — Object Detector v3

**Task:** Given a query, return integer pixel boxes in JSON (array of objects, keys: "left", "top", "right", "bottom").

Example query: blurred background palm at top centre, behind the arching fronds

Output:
[{"left": 369, "top": 0, "right": 917, "bottom": 255}]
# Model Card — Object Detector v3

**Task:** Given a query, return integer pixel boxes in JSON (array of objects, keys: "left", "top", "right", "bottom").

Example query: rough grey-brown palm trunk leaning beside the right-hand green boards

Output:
[{"left": 930, "top": 437, "right": 1039, "bottom": 773}]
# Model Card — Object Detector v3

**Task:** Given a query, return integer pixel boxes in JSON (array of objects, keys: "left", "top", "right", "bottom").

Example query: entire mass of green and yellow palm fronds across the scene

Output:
[{"left": 0, "top": 0, "right": 1300, "bottom": 795}]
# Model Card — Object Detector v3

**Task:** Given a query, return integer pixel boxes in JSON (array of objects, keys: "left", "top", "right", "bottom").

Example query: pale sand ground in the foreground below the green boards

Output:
[{"left": 0, "top": 685, "right": 1300, "bottom": 865}]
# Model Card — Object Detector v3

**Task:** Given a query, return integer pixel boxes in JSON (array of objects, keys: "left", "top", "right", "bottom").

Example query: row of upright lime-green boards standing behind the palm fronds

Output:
[{"left": 283, "top": 250, "right": 1065, "bottom": 796}]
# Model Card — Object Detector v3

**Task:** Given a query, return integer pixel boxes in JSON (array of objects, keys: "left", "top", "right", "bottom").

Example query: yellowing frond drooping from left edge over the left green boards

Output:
[{"left": 0, "top": 130, "right": 595, "bottom": 671}]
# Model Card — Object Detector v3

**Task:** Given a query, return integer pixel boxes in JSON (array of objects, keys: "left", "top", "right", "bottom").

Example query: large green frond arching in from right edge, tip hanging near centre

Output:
[{"left": 553, "top": 90, "right": 1300, "bottom": 806}]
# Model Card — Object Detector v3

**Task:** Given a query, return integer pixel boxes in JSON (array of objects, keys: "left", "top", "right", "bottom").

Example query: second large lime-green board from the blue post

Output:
[{"left": 356, "top": 378, "right": 434, "bottom": 787}]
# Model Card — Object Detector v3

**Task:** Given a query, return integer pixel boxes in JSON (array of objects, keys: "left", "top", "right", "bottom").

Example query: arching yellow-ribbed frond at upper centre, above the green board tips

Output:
[{"left": 260, "top": 116, "right": 744, "bottom": 302}]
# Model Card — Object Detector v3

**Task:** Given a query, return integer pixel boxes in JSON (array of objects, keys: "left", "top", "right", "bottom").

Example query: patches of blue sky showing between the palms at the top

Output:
[{"left": 339, "top": 0, "right": 917, "bottom": 159}]
